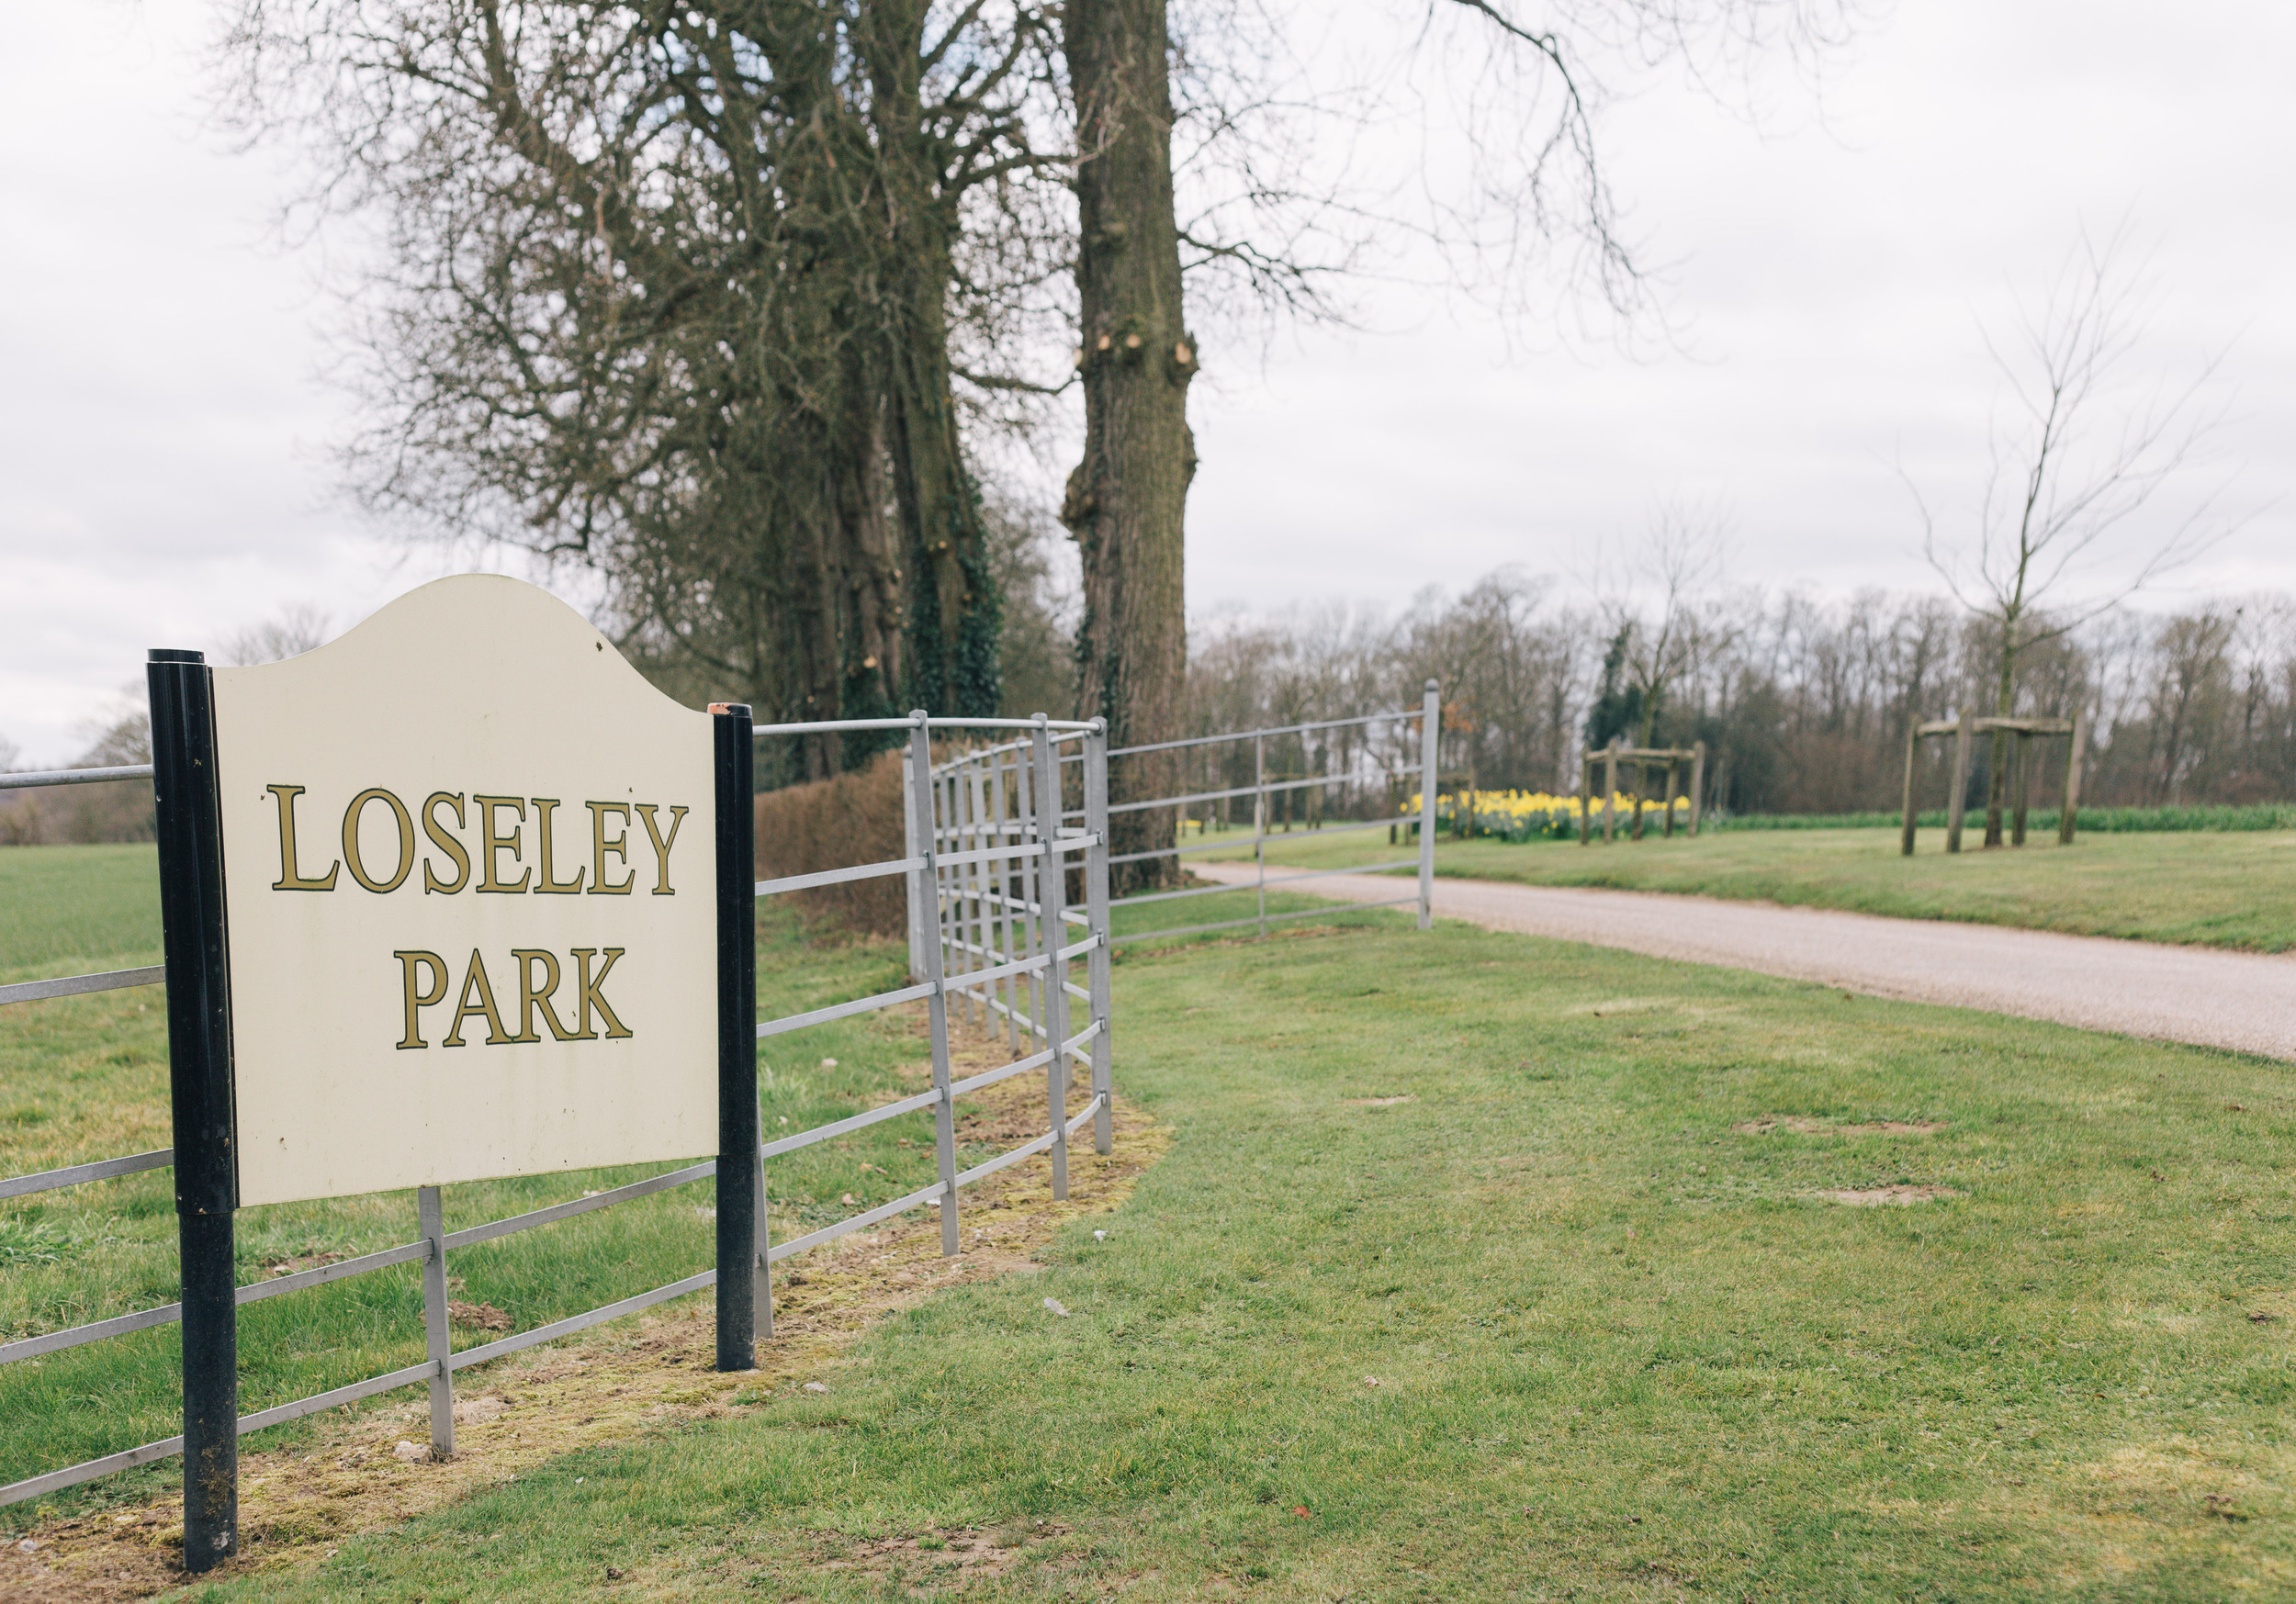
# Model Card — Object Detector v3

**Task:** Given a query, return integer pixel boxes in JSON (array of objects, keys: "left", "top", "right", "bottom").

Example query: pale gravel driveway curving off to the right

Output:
[{"left": 1194, "top": 863, "right": 2296, "bottom": 1060}]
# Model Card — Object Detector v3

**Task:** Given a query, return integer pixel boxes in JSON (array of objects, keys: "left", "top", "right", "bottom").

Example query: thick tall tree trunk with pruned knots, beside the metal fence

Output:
[{"left": 1061, "top": 0, "right": 1197, "bottom": 886}]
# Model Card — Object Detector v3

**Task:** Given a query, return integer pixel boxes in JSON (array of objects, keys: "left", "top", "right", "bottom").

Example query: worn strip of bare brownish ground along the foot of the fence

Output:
[{"left": 0, "top": 1012, "right": 1171, "bottom": 1604}]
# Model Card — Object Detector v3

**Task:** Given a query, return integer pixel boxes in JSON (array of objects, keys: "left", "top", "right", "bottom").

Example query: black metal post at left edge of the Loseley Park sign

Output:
[{"left": 145, "top": 652, "right": 239, "bottom": 1572}]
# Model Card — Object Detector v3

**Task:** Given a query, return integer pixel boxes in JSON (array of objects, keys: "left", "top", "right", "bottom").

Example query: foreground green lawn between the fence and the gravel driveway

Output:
[{"left": 184, "top": 915, "right": 2296, "bottom": 1602}]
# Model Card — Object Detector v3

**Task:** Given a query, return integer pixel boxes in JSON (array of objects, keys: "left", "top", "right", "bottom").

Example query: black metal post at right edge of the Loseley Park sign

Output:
[{"left": 710, "top": 702, "right": 765, "bottom": 1370}]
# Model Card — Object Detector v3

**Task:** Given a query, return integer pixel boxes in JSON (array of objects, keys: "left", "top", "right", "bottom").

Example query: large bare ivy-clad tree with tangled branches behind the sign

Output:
[{"left": 223, "top": 0, "right": 1065, "bottom": 773}]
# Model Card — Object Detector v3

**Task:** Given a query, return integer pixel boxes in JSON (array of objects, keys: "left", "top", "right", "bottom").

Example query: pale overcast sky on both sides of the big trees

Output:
[{"left": 0, "top": 0, "right": 2296, "bottom": 767}]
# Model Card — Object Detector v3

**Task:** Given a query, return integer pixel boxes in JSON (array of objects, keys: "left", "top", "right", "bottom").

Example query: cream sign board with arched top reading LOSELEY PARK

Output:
[{"left": 214, "top": 576, "right": 716, "bottom": 1205}]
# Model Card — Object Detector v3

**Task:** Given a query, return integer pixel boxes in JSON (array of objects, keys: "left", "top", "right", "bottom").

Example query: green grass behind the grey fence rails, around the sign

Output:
[{"left": 0, "top": 903, "right": 992, "bottom": 1524}]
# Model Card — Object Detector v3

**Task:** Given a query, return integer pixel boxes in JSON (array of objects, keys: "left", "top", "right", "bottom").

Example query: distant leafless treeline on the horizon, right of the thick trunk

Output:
[{"left": 1189, "top": 574, "right": 2296, "bottom": 828}]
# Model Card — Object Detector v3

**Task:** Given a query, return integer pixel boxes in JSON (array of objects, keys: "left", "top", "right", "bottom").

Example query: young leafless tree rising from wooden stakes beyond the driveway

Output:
[{"left": 1906, "top": 225, "right": 2230, "bottom": 847}]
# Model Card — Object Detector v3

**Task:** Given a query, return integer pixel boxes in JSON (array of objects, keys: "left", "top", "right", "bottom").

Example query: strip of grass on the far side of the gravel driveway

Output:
[{"left": 1206, "top": 831, "right": 2296, "bottom": 952}]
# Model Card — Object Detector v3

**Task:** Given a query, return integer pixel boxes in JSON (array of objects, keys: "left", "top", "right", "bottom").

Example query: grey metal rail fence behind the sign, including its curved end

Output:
[{"left": 0, "top": 713, "right": 1109, "bottom": 1506}]
